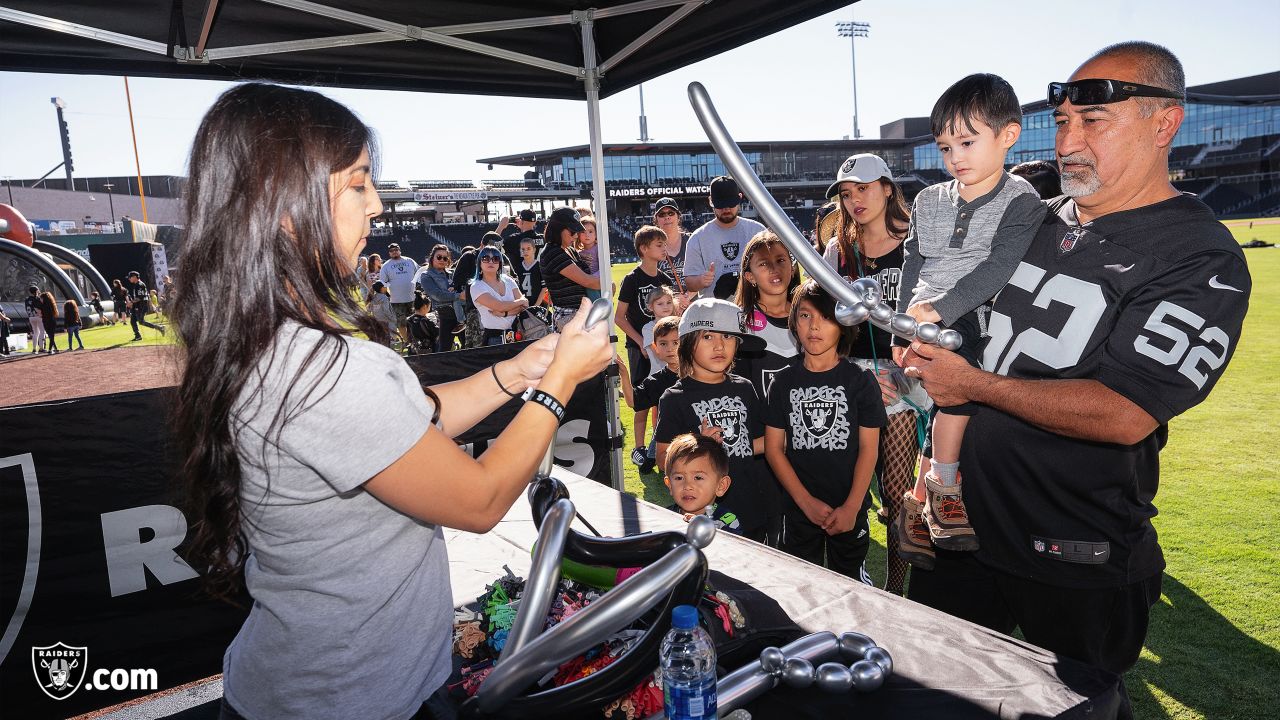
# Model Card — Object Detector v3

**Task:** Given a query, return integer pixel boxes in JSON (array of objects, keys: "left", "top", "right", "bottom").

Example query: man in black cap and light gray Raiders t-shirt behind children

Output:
[{"left": 685, "top": 176, "right": 764, "bottom": 300}]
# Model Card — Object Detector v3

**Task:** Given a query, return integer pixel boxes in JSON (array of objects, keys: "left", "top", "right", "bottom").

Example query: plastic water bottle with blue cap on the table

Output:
[{"left": 659, "top": 605, "right": 716, "bottom": 720}]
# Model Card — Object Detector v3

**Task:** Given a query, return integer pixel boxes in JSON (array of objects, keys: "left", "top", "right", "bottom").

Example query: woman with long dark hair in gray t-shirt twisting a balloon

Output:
[{"left": 173, "top": 83, "right": 612, "bottom": 720}]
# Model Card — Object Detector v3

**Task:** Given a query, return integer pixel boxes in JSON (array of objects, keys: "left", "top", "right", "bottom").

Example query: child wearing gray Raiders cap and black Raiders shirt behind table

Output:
[{"left": 654, "top": 299, "right": 768, "bottom": 541}]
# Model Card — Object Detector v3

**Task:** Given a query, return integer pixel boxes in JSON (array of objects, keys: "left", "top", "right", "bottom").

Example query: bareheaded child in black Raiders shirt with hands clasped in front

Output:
[{"left": 764, "top": 281, "right": 886, "bottom": 584}]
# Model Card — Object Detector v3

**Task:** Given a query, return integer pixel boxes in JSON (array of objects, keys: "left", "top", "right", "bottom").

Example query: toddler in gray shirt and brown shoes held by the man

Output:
[{"left": 892, "top": 73, "right": 1046, "bottom": 569}]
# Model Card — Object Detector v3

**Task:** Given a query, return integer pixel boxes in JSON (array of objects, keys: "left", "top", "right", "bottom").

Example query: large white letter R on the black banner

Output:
[{"left": 102, "top": 505, "right": 200, "bottom": 597}]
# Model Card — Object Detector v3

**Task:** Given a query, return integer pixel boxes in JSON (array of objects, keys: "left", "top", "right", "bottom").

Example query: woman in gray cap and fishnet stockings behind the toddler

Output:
[{"left": 824, "top": 154, "right": 932, "bottom": 594}]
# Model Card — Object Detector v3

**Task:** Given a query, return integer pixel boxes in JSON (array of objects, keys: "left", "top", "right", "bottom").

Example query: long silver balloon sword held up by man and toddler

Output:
[{"left": 689, "top": 82, "right": 960, "bottom": 350}]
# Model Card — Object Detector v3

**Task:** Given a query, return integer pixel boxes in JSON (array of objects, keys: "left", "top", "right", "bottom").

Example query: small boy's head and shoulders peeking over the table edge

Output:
[{"left": 663, "top": 433, "right": 742, "bottom": 536}]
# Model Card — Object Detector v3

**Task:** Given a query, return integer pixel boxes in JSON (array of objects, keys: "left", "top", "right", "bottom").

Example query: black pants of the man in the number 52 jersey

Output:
[{"left": 908, "top": 550, "right": 1164, "bottom": 717}]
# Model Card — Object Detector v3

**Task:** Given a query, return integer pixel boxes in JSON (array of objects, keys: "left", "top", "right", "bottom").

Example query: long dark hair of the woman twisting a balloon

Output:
[{"left": 170, "top": 83, "right": 388, "bottom": 598}]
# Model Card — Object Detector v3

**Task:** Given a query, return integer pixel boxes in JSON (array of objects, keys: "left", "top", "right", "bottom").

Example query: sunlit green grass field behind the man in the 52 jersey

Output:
[{"left": 613, "top": 220, "right": 1280, "bottom": 720}]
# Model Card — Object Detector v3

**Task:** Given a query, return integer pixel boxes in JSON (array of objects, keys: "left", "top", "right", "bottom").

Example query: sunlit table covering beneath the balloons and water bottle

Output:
[{"left": 445, "top": 470, "right": 1119, "bottom": 720}]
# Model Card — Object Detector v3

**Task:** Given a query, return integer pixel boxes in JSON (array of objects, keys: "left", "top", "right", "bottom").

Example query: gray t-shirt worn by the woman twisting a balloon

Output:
[{"left": 223, "top": 323, "right": 453, "bottom": 720}]
